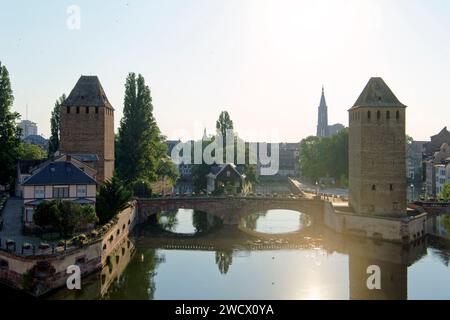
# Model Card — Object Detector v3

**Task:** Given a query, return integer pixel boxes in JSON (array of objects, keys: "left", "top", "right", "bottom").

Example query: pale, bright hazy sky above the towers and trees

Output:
[{"left": 0, "top": 0, "right": 450, "bottom": 142}]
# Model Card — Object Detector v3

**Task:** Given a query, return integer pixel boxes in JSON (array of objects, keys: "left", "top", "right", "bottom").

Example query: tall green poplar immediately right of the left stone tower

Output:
[{"left": 116, "top": 73, "right": 174, "bottom": 184}]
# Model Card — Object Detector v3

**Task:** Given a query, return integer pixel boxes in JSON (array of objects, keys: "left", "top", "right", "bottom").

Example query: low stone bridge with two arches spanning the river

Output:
[{"left": 137, "top": 196, "right": 324, "bottom": 225}]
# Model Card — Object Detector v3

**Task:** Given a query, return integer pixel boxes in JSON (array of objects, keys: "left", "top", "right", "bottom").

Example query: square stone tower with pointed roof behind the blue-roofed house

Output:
[{"left": 60, "top": 76, "right": 114, "bottom": 183}]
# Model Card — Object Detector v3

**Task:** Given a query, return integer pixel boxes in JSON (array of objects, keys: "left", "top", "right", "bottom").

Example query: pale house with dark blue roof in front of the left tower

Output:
[{"left": 22, "top": 157, "right": 97, "bottom": 225}]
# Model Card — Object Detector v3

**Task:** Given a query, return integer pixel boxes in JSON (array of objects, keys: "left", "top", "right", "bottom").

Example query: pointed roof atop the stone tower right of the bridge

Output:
[{"left": 353, "top": 78, "right": 406, "bottom": 108}]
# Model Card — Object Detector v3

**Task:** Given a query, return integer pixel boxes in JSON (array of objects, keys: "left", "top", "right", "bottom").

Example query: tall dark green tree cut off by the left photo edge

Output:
[{"left": 0, "top": 62, "right": 21, "bottom": 189}]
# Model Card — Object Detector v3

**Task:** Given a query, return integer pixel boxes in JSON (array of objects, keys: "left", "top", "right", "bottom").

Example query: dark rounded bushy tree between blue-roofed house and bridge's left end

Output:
[{"left": 96, "top": 175, "right": 132, "bottom": 224}]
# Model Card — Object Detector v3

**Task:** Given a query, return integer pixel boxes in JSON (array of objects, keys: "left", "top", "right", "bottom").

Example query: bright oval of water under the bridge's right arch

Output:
[{"left": 243, "top": 209, "right": 311, "bottom": 234}]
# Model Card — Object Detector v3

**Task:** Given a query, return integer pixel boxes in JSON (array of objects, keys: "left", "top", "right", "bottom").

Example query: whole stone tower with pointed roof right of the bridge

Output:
[{"left": 349, "top": 78, "right": 406, "bottom": 216}]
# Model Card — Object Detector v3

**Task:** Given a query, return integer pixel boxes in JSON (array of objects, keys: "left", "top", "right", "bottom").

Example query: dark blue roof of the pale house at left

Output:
[{"left": 23, "top": 161, "right": 96, "bottom": 186}]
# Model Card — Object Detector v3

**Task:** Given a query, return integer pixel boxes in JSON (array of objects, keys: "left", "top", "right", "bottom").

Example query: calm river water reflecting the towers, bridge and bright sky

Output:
[{"left": 41, "top": 209, "right": 450, "bottom": 300}]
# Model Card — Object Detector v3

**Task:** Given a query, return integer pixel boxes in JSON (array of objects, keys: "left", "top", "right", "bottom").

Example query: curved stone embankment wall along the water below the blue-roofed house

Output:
[{"left": 0, "top": 203, "right": 137, "bottom": 296}]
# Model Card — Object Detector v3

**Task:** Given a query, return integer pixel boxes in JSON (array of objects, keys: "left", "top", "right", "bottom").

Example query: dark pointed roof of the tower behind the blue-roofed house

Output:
[{"left": 62, "top": 76, "right": 114, "bottom": 109}]
